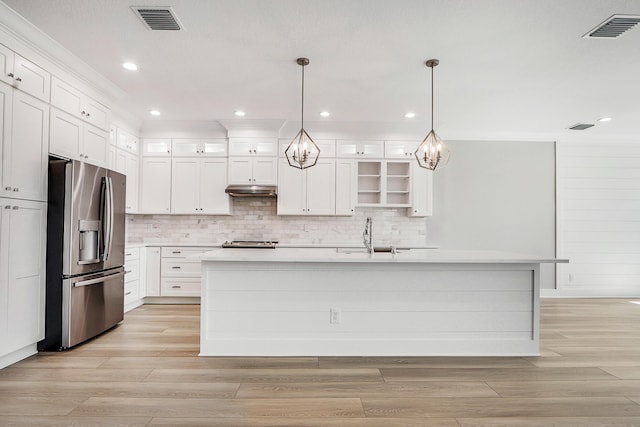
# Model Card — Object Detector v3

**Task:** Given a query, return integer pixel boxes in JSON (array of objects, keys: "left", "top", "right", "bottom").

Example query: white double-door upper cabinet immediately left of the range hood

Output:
[{"left": 171, "top": 158, "right": 229, "bottom": 215}]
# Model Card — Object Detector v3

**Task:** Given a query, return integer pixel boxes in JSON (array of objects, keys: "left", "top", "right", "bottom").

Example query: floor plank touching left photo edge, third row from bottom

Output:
[{"left": 0, "top": 381, "right": 240, "bottom": 400}]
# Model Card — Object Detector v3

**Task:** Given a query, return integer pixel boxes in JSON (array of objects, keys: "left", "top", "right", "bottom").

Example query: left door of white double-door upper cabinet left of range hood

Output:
[{"left": 171, "top": 157, "right": 200, "bottom": 214}]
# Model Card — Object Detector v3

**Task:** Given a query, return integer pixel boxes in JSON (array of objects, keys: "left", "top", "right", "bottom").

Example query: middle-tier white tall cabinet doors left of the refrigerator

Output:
[{"left": 0, "top": 87, "right": 49, "bottom": 201}]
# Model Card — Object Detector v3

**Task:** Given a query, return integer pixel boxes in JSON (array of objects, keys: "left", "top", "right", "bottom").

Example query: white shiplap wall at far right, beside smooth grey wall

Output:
[{"left": 557, "top": 142, "right": 640, "bottom": 296}]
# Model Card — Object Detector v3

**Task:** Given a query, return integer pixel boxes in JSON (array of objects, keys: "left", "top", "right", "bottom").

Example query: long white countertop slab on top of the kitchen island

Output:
[{"left": 193, "top": 246, "right": 569, "bottom": 264}]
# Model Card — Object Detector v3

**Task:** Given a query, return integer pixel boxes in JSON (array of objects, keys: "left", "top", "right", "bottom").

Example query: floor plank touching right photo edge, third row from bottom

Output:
[{"left": 487, "top": 380, "right": 640, "bottom": 397}]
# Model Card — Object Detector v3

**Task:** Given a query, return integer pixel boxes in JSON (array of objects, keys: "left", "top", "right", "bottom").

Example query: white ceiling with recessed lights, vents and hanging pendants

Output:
[{"left": 4, "top": 0, "right": 640, "bottom": 139}]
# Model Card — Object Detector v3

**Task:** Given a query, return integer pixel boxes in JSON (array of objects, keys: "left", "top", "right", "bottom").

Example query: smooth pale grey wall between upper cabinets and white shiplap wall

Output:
[{"left": 427, "top": 141, "right": 555, "bottom": 289}]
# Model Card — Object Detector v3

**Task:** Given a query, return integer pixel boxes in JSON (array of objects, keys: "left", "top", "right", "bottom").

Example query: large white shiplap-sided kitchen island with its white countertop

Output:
[{"left": 199, "top": 248, "right": 558, "bottom": 356}]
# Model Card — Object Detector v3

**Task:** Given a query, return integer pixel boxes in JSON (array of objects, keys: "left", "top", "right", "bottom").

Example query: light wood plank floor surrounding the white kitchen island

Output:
[{"left": 0, "top": 299, "right": 640, "bottom": 427}]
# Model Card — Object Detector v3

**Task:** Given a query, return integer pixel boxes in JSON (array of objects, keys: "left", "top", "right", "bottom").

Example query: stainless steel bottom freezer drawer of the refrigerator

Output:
[{"left": 62, "top": 268, "right": 124, "bottom": 348}]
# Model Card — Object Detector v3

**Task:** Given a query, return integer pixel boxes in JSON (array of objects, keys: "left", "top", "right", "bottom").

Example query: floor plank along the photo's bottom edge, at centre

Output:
[{"left": 149, "top": 417, "right": 460, "bottom": 427}]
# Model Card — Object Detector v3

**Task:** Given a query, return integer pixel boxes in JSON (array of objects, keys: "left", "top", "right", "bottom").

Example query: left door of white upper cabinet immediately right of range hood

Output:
[{"left": 277, "top": 159, "right": 304, "bottom": 215}]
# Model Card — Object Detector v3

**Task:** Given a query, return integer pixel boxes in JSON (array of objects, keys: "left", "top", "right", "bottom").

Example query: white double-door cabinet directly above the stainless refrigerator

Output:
[{"left": 49, "top": 108, "right": 109, "bottom": 166}]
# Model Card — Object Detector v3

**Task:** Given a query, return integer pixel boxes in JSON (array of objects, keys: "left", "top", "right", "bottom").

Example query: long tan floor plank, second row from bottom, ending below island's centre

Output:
[{"left": 71, "top": 397, "right": 364, "bottom": 418}]
